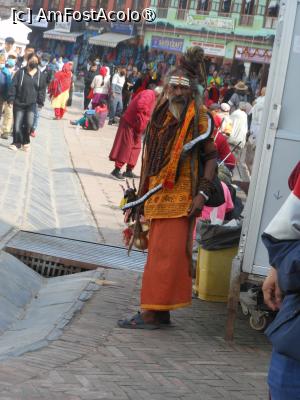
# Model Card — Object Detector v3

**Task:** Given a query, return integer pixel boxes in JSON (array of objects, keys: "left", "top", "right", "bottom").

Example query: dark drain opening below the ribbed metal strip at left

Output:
[{"left": 4, "top": 247, "right": 97, "bottom": 278}]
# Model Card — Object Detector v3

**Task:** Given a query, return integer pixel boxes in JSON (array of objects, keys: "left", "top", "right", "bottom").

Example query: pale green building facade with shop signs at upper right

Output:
[{"left": 144, "top": 0, "right": 279, "bottom": 77}]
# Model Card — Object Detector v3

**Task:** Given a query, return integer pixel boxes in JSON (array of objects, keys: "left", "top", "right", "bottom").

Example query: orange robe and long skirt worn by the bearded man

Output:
[{"left": 141, "top": 102, "right": 215, "bottom": 311}]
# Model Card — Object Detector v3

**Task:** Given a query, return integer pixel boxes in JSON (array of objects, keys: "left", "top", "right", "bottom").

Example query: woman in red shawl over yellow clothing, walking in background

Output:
[{"left": 48, "top": 63, "right": 72, "bottom": 120}]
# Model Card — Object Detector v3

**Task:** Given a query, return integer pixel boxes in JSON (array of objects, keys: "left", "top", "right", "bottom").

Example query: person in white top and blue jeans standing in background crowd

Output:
[{"left": 108, "top": 67, "right": 126, "bottom": 125}]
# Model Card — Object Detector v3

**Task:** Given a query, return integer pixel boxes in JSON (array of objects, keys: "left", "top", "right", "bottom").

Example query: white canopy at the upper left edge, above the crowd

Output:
[{"left": 0, "top": 18, "right": 32, "bottom": 55}]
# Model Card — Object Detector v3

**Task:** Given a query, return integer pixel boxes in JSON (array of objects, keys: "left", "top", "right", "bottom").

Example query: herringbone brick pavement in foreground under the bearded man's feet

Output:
[{"left": 0, "top": 270, "right": 270, "bottom": 400}]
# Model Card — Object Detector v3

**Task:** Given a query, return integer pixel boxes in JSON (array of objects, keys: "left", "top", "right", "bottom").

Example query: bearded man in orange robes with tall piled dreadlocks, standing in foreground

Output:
[{"left": 118, "top": 46, "right": 218, "bottom": 329}]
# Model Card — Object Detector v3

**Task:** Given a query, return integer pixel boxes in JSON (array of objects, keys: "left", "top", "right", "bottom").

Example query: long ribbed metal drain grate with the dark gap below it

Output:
[{"left": 4, "top": 231, "right": 147, "bottom": 276}]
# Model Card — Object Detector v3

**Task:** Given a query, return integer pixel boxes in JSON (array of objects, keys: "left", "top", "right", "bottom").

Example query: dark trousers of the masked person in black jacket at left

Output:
[{"left": 13, "top": 104, "right": 35, "bottom": 145}]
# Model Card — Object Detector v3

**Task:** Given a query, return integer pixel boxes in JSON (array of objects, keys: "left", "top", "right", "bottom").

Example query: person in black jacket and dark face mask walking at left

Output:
[{"left": 8, "top": 54, "right": 46, "bottom": 151}]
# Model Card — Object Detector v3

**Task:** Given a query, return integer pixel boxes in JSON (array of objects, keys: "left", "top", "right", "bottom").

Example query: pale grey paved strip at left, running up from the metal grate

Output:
[{"left": 0, "top": 100, "right": 100, "bottom": 241}]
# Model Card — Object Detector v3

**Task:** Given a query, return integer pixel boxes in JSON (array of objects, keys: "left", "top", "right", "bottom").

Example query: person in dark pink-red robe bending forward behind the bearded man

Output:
[{"left": 109, "top": 88, "right": 160, "bottom": 180}]
